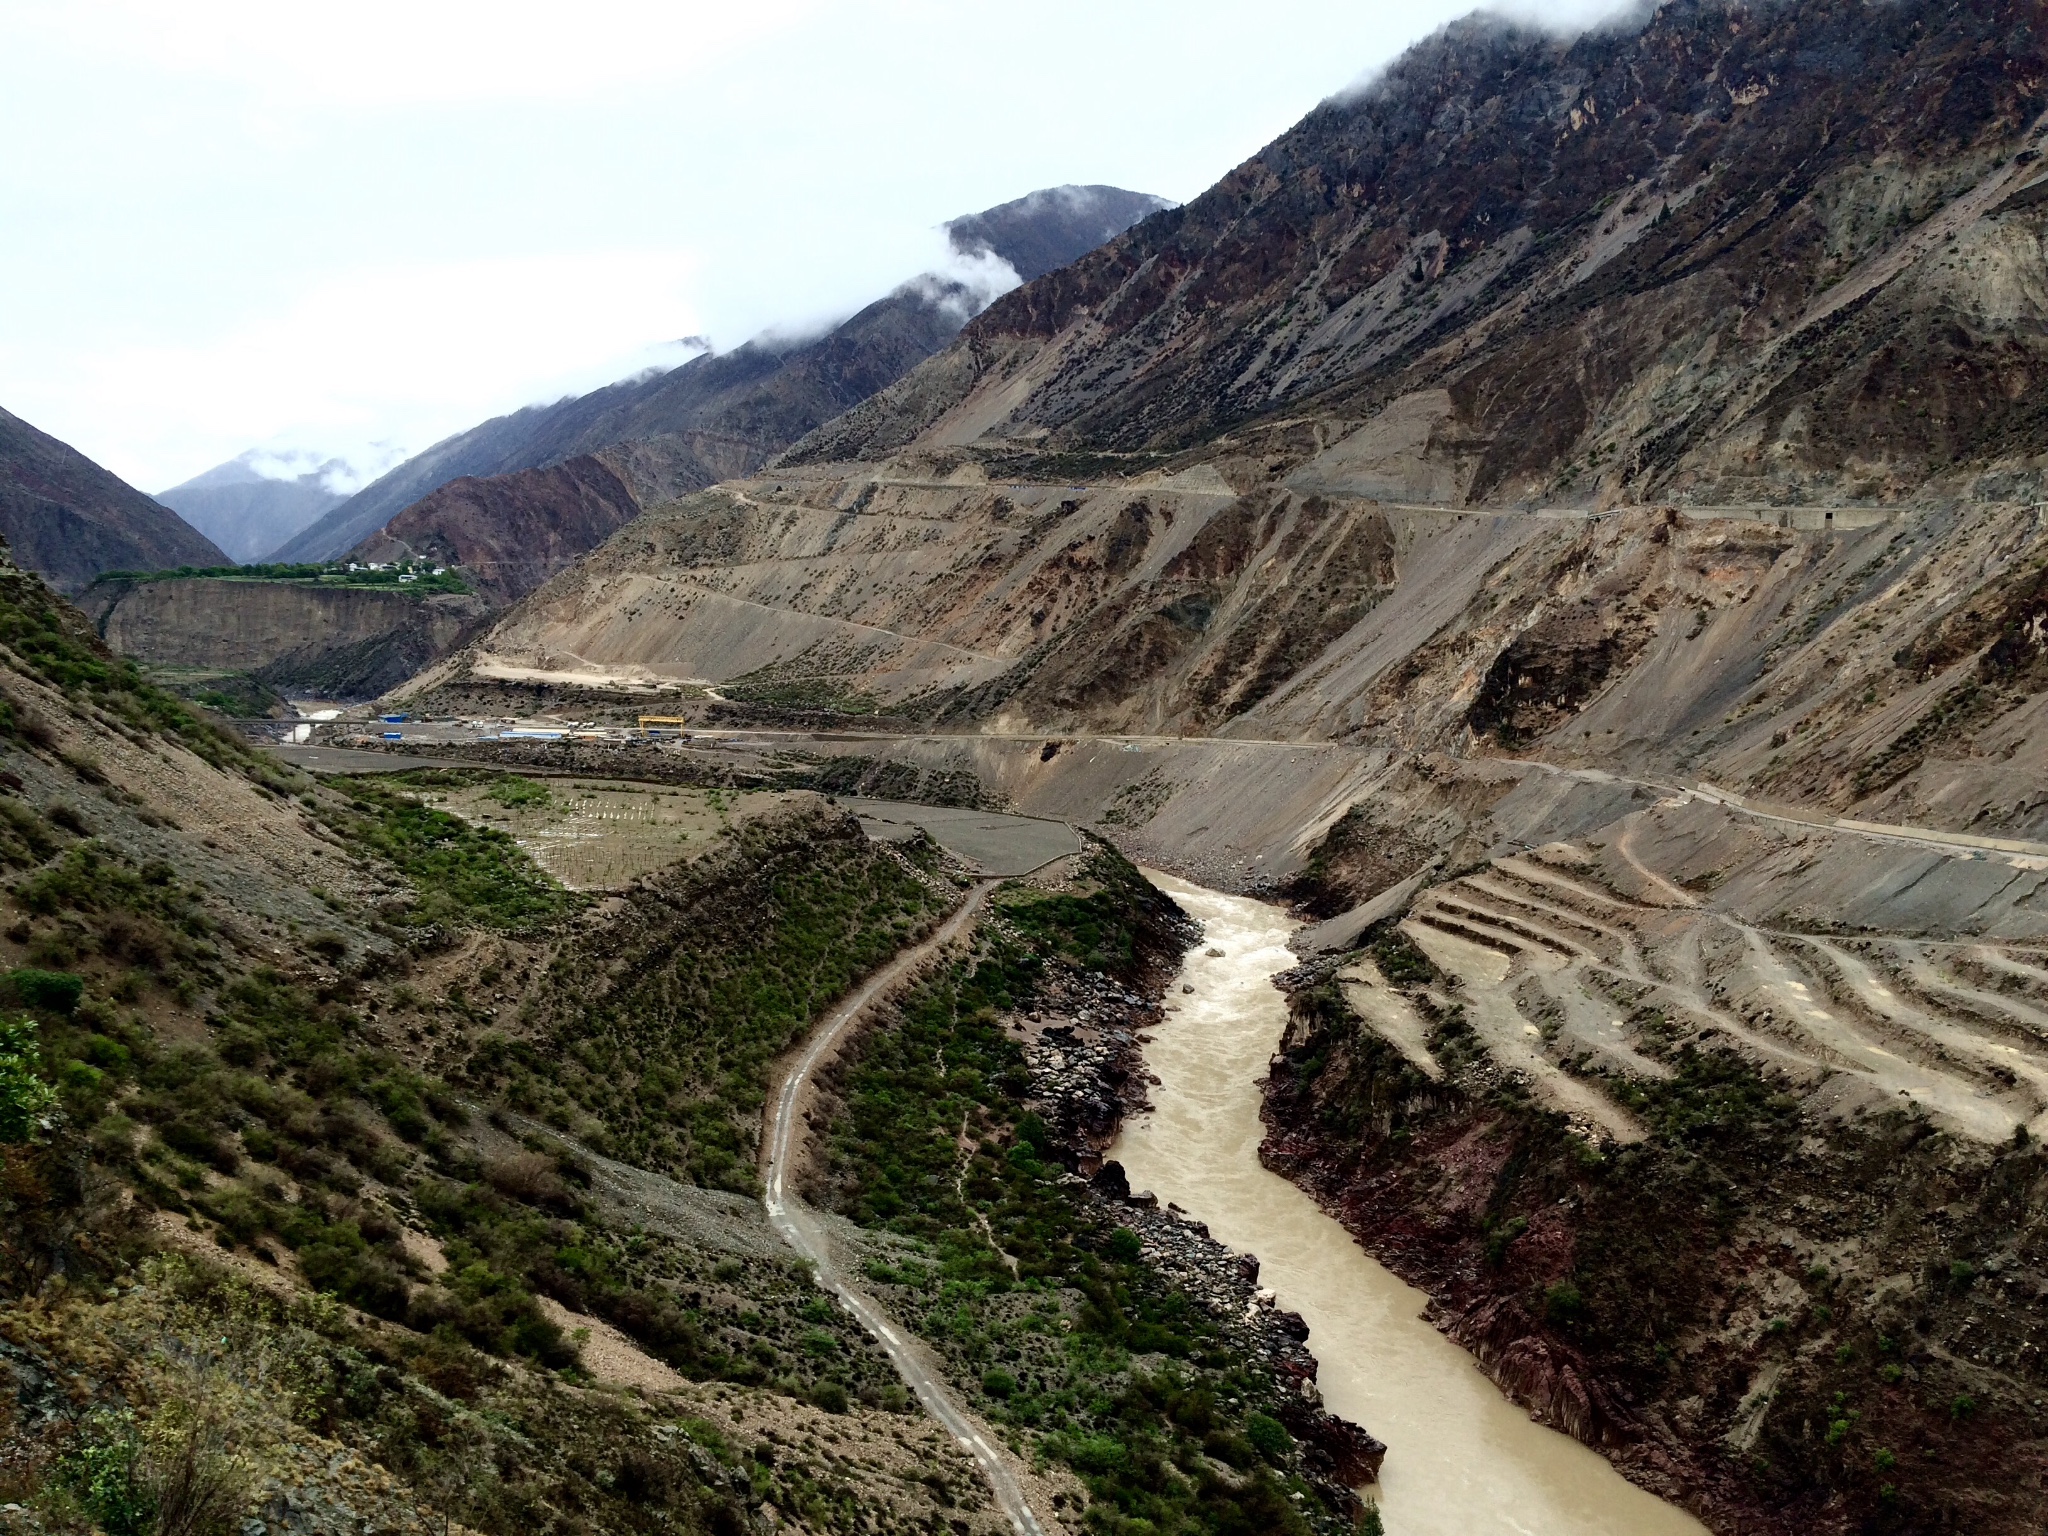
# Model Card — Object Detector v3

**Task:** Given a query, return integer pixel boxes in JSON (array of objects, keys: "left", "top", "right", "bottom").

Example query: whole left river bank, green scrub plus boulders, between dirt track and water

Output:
[{"left": 791, "top": 842, "right": 1358, "bottom": 1536}]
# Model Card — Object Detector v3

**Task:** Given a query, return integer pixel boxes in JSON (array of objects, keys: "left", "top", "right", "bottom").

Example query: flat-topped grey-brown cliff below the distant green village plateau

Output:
[{"left": 84, "top": 580, "right": 487, "bottom": 698}]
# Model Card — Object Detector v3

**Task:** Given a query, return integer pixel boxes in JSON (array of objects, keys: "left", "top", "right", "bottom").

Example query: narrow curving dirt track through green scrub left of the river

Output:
[{"left": 762, "top": 881, "right": 1044, "bottom": 1536}]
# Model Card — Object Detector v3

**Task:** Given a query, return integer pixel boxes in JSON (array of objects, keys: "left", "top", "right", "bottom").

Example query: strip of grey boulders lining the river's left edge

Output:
[{"left": 1010, "top": 967, "right": 1386, "bottom": 1507}]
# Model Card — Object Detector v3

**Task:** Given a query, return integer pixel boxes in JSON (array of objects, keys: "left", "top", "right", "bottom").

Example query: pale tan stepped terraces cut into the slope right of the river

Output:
[{"left": 1400, "top": 844, "right": 2048, "bottom": 1145}]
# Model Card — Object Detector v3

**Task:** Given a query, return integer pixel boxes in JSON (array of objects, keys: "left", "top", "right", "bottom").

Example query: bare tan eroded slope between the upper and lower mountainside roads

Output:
[{"left": 436, "top": 453, "right": 2048, "bottom": 836}]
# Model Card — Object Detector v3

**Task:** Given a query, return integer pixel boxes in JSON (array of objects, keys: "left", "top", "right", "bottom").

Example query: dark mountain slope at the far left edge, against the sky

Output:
[{"left": 0, "top": 410, "right": 229, "bottom": 592}]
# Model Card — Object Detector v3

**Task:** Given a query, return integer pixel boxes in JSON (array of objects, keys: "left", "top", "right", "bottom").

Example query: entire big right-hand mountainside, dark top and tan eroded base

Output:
[{"left": 428, "top": 0, "right": 2048, "bottom": 829}]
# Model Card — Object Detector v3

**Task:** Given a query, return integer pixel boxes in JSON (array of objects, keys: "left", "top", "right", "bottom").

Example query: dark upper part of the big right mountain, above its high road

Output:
[{"left": 791, "top": 0, "right": 2048, "bottom": 504}]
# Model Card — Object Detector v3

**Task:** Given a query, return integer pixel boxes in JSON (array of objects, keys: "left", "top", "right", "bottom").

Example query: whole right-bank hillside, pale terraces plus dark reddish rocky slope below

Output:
[{"left": 1266, "top": 795, "right": 2048, "bottom": 1532}]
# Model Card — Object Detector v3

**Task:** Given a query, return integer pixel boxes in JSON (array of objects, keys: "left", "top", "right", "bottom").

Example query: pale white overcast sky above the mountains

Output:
[{"left": 0, "top": 0, "right": 1622, "bottom": 492}]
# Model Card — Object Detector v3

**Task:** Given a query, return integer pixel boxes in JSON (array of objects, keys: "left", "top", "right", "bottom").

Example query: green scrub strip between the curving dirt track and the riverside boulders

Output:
[{"left": 829, "top": 860, "right": 1319, "bottom": 1532}]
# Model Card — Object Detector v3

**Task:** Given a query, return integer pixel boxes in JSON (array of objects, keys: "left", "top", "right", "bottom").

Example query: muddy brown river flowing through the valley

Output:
[{"left": 1110, "top": 874, "right": 1706, "bottom": 1536}]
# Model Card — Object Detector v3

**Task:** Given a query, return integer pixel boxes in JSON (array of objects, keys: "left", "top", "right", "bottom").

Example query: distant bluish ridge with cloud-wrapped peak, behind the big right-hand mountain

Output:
[{"left": 276, "top": 186, "right": 1167, "bottom": 573}]
